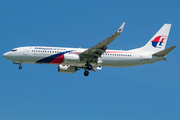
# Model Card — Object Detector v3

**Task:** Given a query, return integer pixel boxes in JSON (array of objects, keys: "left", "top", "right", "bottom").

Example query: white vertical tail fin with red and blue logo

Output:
[{"left": 132, "top": 24, "right": 171, "bottom": 53}]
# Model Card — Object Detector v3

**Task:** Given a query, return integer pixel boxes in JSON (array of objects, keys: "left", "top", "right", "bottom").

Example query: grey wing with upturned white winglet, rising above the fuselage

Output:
[{"left": 80, "top": 22, "right": 125, "bottom": 61}]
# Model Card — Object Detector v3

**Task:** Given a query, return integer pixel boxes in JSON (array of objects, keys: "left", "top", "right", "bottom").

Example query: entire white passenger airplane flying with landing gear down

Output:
[{"left": 3, "top": 22, "right": 176, "bottom": 76}]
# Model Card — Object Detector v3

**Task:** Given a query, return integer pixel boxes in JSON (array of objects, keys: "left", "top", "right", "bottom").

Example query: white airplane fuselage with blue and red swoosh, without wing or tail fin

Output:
[{"left": 3, "top": 46, "right": 164, "bottom": 67}]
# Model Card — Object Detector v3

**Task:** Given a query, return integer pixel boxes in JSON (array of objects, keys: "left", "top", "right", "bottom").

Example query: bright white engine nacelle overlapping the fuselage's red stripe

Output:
[{"left": 64, "top": 54, "right": 80, "bottom": 63}]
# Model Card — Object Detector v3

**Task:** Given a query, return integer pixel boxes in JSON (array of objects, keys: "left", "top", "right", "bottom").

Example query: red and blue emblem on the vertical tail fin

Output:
[{"left": 151, "top": 36, "right": 167, "bottom": 47}]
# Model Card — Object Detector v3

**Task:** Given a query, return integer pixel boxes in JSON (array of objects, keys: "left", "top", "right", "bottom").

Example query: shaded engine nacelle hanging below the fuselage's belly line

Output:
[{"left": 58, "top": 65, "right": 77, "bottom": 73}]
